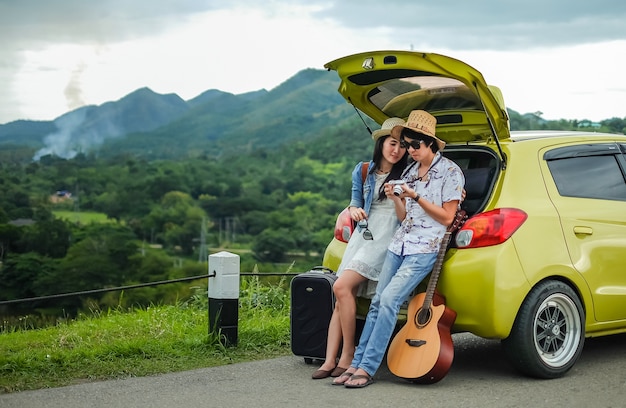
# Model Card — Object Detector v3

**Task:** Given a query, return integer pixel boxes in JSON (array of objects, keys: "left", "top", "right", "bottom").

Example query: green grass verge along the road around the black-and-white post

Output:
[{"left": 0, "top": 278, "right": 290, "bottom": 393}]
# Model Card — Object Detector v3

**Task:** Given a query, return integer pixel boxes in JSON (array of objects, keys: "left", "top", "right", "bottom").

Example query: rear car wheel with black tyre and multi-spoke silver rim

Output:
[{"left": 502, "top": 280, "right": 585, "bottom": 379}]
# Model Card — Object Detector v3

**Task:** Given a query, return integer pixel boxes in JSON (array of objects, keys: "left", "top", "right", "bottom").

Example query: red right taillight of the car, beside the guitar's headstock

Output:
[{"left": 455, "top": 208, "right": 528, "bottom": 248}]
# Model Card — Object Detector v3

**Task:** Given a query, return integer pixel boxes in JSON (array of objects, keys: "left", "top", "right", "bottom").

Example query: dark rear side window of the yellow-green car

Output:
[{"left": 544, "top": 145, "right": 626, "bottom": 201}]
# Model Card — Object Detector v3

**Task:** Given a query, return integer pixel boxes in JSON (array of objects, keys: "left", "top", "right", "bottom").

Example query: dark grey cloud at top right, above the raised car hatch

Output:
[{"left": 319, "top": 0, "right": 626, "bottom": 50}]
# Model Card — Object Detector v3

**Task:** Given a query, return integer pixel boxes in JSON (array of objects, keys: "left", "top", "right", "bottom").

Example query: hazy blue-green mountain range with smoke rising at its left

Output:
[{"left": 0, "top": 69, "right": 354, "bottom": 160}]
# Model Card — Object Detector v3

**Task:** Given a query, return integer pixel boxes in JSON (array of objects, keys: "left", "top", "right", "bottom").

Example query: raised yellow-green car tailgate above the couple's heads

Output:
[{"left": 324, "top": 50, "right": 510, "bottom": 143}]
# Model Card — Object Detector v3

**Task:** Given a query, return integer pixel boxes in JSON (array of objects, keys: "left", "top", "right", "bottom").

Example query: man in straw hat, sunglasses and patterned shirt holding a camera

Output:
[{"left": 334, "top": 110, "right": 465, "bottom": 388}]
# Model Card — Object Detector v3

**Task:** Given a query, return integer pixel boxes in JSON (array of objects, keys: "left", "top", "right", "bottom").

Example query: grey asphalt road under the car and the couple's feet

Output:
[{"left": 0, "top": 334, "right": 626, "bottom": 408}]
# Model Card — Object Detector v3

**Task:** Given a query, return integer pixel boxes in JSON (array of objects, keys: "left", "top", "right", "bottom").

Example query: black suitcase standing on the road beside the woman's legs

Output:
[{"left": 290, "top": 267, "right": 337, "bottom": 364}]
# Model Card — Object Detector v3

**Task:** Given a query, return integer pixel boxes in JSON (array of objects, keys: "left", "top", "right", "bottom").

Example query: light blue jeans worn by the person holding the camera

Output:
[{"left": 351, "top": 251, "right": 437, "bottom": 375}]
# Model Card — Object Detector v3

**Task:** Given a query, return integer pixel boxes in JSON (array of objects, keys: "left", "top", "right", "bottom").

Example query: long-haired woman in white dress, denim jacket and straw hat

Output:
[{"left": 312, "top": 118, "right": 407, "bottom": 379}]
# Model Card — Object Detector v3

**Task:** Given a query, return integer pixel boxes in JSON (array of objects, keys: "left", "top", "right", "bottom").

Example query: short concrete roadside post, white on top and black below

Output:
[{"left": 209, "top": 251, "right": 240, "bottom": 346}]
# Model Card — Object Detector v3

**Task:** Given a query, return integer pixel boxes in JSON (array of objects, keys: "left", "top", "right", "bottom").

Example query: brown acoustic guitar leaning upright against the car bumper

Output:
[{"left": 387, "top": 210, "right": 466, "bottom": 384}]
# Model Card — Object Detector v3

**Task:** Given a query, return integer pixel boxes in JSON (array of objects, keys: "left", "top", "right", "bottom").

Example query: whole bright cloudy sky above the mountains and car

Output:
[{"left": 0, "top": 0, "right": 626, "bottom": 124}]
